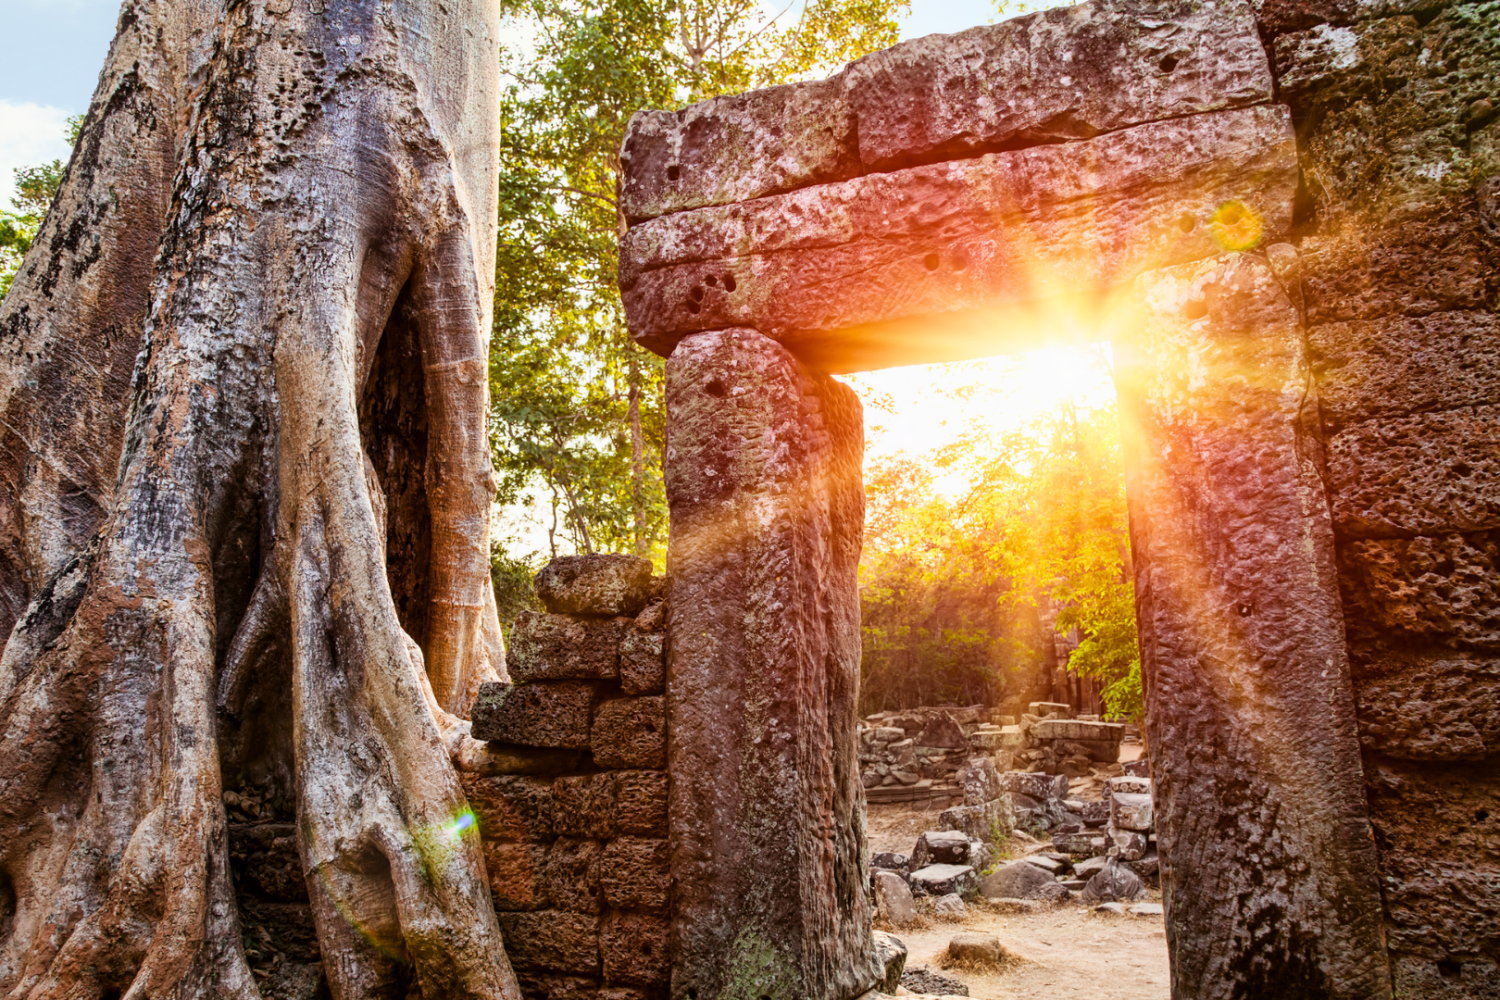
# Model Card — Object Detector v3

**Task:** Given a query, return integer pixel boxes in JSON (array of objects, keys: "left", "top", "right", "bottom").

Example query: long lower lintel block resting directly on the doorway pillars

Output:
[{"left": 620, "top": 106, "right": 1298, "bottom": 370}]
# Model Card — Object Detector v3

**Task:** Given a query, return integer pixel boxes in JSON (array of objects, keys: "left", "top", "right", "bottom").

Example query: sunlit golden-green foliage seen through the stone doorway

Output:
[{"left": 860, "top": 355, "right": 1143, "bottom": 720}]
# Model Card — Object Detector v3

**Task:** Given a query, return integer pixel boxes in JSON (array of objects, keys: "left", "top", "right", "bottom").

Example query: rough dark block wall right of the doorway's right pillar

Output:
[{"left": 1260, "top": 0, "right": 1500, "bottom": 999}]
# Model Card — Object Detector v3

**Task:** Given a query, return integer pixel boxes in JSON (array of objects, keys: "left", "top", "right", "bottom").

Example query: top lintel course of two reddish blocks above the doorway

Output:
[{"left": 621, "top": 0, "right": 1272, "bottom": 223}]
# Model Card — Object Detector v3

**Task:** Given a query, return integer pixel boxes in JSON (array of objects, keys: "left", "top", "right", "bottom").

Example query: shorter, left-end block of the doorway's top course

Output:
[{"left": 620, "top": 78, "right": 860, "bottom": 222}]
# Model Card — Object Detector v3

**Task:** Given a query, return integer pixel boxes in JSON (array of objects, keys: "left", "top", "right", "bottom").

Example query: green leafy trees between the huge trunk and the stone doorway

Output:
[{"left": 491, "top": 0, "right": 906, "bottom": 565}]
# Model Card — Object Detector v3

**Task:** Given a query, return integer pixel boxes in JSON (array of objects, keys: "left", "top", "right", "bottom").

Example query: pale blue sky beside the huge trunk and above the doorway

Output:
[{"left": 0, "top": 0, "right": 996, "bottom": 208}]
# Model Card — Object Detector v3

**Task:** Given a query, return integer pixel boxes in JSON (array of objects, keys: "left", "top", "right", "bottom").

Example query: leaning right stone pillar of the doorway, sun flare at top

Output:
[{"left": 1116, "top": 251, "right": 1391, "bottom": 1000}]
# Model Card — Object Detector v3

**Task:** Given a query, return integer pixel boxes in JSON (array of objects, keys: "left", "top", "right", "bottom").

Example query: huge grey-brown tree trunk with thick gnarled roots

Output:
[{"left": 0, "top": 0, "right": 519, "bottom": 1000}]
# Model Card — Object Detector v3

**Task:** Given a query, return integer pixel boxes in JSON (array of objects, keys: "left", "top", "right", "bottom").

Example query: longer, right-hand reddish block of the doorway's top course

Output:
[{"left": 845, "top": 0, "right": 1272, "bottom": 171}]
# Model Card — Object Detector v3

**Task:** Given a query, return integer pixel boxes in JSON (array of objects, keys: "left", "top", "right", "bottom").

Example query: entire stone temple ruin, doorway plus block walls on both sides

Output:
[{"left": 228, "top": 0, "right": 1500, "bottom": 1000}]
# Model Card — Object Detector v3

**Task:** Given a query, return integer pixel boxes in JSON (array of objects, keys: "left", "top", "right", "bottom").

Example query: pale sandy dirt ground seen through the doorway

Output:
[{"left": 869, "top": 748, "right": 1172, "bottom": 1000}]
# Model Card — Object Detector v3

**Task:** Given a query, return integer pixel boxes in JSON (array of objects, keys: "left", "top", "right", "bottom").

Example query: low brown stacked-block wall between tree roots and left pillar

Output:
[{"left": 464, "top": 556, "right": 671, "bottom": 1000}]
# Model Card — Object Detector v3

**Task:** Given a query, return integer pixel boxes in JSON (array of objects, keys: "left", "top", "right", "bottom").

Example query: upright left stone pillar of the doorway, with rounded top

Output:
[{"left": 666, "top": 330, "right": 878, "bottom": 1000}]
